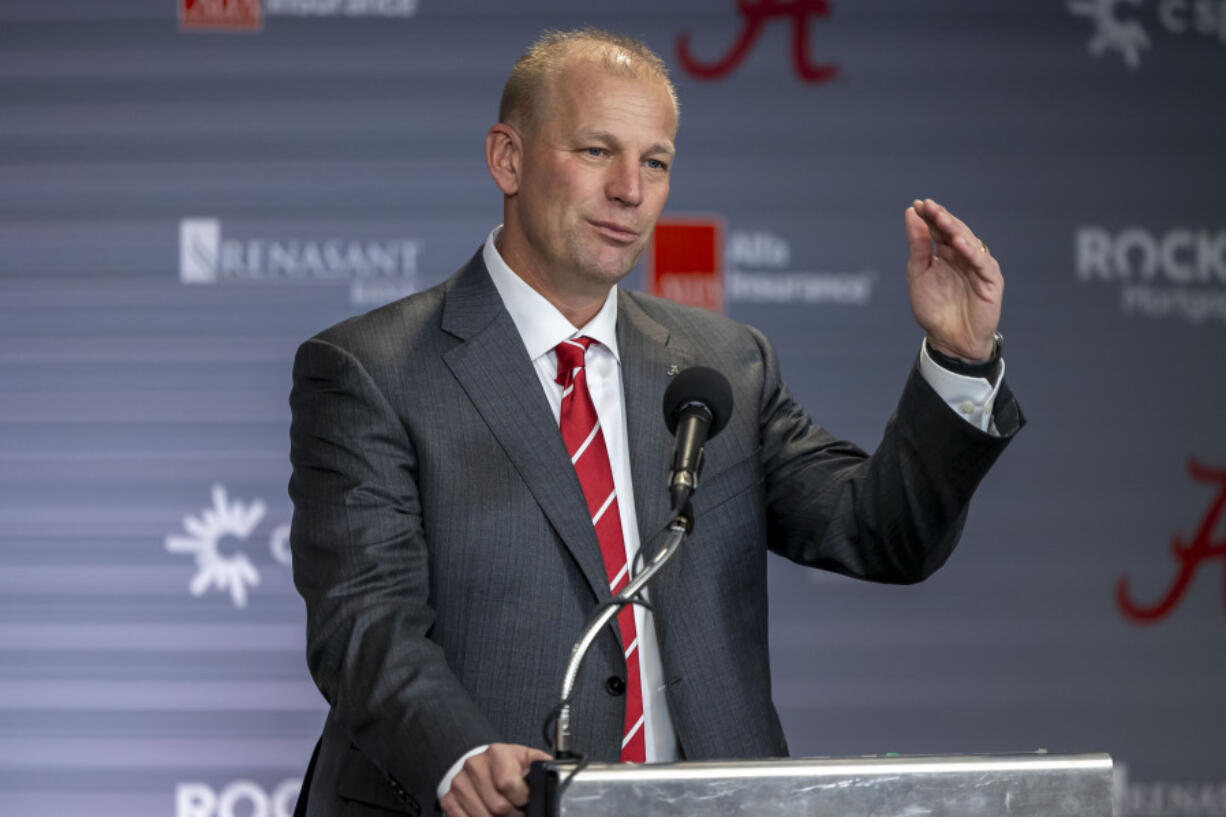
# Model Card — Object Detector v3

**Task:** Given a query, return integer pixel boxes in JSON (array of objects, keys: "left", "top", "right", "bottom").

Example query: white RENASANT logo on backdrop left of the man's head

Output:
[{"left": 179, "top": 218, "right": 422, "bottom": 307}]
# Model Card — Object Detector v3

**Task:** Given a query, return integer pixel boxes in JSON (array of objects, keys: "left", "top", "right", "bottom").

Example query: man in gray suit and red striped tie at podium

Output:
[{"left": 289, "top": 31, "right": 1021, "bottom": 817}]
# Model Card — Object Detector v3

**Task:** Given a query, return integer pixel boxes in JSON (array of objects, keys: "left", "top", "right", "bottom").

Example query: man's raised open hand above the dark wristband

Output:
[{"left": 905, "top": 199, "right": 1004, "bottom": 362}]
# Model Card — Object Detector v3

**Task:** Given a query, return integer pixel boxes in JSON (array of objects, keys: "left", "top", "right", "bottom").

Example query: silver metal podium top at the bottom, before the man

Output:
[{"left": 528, "top": 753, "right": 1112, "bottom": 817}]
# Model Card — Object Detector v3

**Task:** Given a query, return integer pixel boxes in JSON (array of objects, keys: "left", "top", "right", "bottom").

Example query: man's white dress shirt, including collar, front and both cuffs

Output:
[{"left": 438, "top": 226, "right": 1004, "bottom": 800}]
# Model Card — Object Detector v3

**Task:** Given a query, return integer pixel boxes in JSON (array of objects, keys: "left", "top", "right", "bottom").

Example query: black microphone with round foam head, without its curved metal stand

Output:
[{"left": 664, "top": 366, "right": 732, "bottom": 512}]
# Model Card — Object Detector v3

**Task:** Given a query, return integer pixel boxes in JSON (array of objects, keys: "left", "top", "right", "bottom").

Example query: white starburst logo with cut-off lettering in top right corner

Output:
[{"left": 1068, "top": 0, "right": 1226, "bottom": 70}]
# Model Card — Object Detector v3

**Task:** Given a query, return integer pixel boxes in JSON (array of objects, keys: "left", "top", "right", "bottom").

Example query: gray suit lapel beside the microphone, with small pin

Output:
[{"left": 617, "top": 291, "right": 694, "bottom": 556}]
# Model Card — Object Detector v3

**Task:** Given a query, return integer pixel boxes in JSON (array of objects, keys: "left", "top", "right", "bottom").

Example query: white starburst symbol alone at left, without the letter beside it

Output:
[{"left": 166, "top": 485, "right": 265, "bottom": 607}]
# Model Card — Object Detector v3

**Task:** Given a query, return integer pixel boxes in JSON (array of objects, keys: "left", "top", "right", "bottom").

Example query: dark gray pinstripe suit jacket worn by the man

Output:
[{"left": 289, "top": 251, "right": 1022, "bottom": 815}]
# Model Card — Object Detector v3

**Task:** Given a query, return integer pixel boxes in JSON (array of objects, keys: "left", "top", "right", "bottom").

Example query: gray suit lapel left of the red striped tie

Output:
[{"left": 443, "top": 251, "right": 613, "bottom": 599}]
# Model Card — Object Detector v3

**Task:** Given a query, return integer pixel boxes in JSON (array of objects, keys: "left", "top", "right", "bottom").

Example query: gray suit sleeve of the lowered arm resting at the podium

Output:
[{"left": 289, "top": 339, "right": 499, "bottom": 800}]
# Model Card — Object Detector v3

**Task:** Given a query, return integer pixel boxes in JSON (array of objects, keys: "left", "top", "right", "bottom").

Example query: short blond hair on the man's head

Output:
[{"left": 498, "top": 27, "right": 680, "bottom": 129}]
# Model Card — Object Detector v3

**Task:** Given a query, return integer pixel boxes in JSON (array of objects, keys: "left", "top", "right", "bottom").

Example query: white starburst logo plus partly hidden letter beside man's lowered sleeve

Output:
[{"left": 166, "top": 483, "right": 291, "bottom": 610}]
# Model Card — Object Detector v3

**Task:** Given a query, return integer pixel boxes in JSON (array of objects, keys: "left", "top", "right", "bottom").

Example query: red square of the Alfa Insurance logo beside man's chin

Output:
[{"left": 647, "top": 216, "right": 723, "bottom": 312}]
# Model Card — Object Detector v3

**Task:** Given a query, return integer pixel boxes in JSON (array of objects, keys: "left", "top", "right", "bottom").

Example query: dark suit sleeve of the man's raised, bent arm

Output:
[{"left": 752, "top": 321, "right": 1024, "bottom": 584}]
